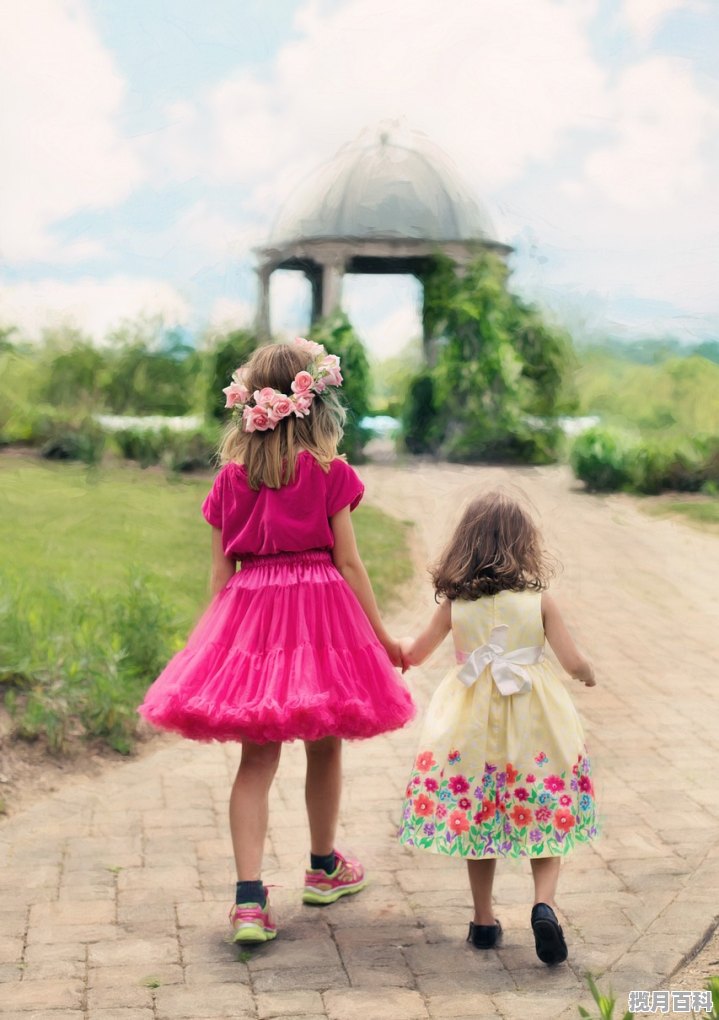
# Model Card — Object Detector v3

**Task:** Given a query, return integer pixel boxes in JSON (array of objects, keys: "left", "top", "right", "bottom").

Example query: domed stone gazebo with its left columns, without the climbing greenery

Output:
[{"left": 257, "top": 125, "right": 512, "bottom": 350}]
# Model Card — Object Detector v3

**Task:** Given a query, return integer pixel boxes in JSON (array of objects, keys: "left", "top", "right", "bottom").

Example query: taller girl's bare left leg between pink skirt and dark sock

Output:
[{"left": 229, "top": 741, "right": 283, "bottom": 881}]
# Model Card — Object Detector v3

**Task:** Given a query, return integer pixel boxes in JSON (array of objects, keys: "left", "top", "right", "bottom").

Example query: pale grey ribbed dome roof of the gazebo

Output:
[{"left": 269, "top": 125, "right": 494, "bottom": 248}]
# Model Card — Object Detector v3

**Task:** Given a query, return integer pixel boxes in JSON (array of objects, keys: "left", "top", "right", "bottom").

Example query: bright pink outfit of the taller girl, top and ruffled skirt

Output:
[{"left": 139, "top": 459, "right": 414, "bottom": 744}]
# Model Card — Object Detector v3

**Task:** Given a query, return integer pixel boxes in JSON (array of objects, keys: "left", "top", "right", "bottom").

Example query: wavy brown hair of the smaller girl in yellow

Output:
[{"left": 430, "top": 490, "right": 555, "bottom": 601}]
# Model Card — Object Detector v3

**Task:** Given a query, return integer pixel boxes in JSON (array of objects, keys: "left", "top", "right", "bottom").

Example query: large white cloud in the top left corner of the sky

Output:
[{"left": 0, "top": 0, "right": 142, "bottom": 262}]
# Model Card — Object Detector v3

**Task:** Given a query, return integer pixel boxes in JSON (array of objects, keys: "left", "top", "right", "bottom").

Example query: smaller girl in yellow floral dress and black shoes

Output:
[{"left": 399, "top": 492, "right": 597, "bottom": 966}]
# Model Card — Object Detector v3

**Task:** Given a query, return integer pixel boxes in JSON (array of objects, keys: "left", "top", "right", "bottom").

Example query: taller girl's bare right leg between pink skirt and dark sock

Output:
[{"left": 305, "top": 736, "right": 342, "bottom": 857}]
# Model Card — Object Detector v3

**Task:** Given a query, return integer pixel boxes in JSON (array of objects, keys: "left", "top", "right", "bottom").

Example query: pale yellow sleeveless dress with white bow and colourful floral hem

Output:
[{"left": 399, "top": 592, "right": 598, "bottom": 858}]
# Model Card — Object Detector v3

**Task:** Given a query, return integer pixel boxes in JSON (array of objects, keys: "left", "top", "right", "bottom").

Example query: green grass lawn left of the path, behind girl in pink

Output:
[{"left": 0, "top": 455, "right": 412, "bottom": 751}]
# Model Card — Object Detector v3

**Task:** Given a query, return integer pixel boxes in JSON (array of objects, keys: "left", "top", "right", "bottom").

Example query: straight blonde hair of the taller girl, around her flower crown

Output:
[{"left": 218, "top": 344, "right": 346, "bottom": 490}]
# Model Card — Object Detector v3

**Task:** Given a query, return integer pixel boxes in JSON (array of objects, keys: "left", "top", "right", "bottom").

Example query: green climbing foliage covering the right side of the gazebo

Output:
[{"left": 405, "top": 252, "right": 571, "bottom": 461}]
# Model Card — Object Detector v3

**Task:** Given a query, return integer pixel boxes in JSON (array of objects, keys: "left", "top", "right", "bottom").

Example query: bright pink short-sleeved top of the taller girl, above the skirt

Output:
[{"left": 202, "top": 450, "right": 364, "bottom": 560}]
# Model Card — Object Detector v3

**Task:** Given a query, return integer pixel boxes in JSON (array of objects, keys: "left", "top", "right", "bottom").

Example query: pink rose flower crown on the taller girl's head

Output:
[{"left": 222, "top": 337, "right": 342, "bottom": 432}]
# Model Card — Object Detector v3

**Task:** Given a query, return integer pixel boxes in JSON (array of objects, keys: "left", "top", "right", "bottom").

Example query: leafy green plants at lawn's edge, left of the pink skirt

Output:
[{"left": 0, "top": 572, "right": 179, "bottom": 754}]
